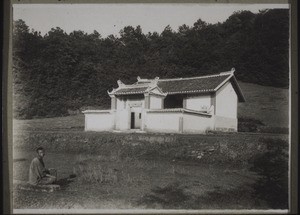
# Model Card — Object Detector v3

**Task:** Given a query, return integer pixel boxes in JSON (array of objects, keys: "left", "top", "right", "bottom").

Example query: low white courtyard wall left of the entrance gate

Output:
[{"left": 84, "top": 112, "right": 114, "bottom": 131}]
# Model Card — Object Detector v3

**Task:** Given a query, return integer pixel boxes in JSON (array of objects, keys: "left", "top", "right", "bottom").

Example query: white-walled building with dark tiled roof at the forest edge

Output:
[{"left": 83, "top": 70, "right": 245, "bottom": 133}]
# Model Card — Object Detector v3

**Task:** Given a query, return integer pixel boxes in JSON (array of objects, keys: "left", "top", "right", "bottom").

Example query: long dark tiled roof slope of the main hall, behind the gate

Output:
[{"left": 157, "top": 74, "right": 230, "bottom": 94}]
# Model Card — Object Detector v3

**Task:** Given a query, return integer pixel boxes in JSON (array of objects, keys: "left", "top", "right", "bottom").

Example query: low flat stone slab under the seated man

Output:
[{"left": 13, "top": 180, "right": 60, "bottom": 193}]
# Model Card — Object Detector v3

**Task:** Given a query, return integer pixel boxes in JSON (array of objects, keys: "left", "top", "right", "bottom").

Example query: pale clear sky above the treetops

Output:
[{"left": 13, "top": 3, "right": 289, "bottom": 37}]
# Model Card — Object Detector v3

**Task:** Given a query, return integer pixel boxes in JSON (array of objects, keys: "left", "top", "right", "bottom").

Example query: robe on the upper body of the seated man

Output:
[{"left": 29, "top": 158, "right": 47, "bottom": 185}]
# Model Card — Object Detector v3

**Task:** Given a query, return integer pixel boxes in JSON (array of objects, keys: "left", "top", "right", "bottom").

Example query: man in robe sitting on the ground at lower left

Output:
[{"left": 29, "top": 147, "right": 56, "bottom": 185}]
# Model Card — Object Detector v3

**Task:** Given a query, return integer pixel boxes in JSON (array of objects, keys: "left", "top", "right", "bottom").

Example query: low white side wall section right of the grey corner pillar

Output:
[{"left": 183, "top": 113, "right": 214, "bottom": 133}]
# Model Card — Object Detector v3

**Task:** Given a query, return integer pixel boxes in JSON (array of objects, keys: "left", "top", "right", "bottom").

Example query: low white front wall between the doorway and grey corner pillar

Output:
[{"left": 145, "top": 112, "right": 182, "bottom": 132}]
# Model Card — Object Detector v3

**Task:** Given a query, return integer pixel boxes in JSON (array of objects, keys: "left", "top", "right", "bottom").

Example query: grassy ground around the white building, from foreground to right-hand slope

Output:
[{"left": 13, "top": 83, "right": 288, "bottom": 209}]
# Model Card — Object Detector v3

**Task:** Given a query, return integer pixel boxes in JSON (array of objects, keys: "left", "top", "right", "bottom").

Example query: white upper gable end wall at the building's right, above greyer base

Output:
[{"left": 215, "top": 82, "right": 238, "bottom": 118}]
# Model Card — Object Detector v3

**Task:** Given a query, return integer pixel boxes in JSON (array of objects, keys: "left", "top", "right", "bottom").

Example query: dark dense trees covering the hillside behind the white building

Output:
[{"left": 13, "top": 9, "right": 289, "bottom": 119}]
